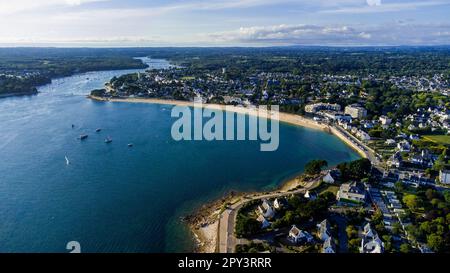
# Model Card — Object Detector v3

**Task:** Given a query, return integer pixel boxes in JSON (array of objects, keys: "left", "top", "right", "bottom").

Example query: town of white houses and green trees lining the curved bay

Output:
[{"left": 91, "top": 47, "right": 450, "bottom": 253}]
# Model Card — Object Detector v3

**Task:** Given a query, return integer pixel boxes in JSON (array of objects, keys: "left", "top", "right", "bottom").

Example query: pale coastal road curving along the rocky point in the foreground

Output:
[{"left": 218, "top": 177, "right": 322, "bottom": 253}]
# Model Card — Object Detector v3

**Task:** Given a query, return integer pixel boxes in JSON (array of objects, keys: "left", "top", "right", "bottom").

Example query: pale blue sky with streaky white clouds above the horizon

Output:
[{"left": 0, "top": 0, "right": 450, "bottom": 47}]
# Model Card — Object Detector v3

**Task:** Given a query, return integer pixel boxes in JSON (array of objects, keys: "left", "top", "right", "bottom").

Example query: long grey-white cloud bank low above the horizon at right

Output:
[{"left": 203, "top": 24, "right": 450, "bottom": 46}]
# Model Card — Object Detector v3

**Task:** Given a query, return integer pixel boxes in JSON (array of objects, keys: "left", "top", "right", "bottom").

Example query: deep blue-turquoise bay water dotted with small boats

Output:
[{"left": 0, "top": 58, "right": 358, "bottom": 252}]
